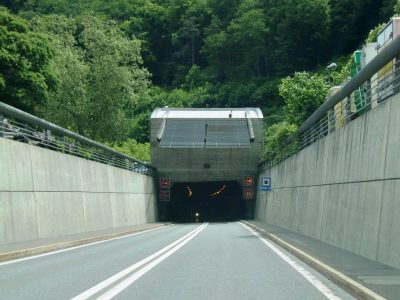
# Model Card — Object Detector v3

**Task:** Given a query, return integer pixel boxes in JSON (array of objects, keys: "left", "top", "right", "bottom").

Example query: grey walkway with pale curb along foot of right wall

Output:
[{"left": 242, "top": 221, "right": 400, "bottom": 299}]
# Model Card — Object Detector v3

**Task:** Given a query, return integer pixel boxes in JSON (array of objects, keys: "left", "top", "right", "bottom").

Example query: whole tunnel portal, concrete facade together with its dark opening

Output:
[{"left": 150, "top": 107, "right": 264, "bottom": 222}]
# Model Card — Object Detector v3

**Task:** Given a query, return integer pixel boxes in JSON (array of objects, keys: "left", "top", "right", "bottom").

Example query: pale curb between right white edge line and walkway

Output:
[{"left": 240, "top": 220, "right": 386, "bottom": 300}]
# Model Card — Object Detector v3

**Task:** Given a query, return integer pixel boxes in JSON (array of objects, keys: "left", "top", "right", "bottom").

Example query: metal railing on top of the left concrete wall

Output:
[{"left": 0, "top": 102, "right": 156, "bottom": 176}]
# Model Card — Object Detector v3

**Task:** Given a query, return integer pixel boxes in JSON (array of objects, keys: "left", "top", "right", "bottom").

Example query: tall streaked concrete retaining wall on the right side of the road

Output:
[{"left": 255, "top": 94, "right": 400, "bottom": 268}]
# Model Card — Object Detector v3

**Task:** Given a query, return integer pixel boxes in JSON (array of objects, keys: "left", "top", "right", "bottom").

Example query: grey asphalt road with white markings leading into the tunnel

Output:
[{"left": 0, "top": 223, "right": 352, "bottom": 300}]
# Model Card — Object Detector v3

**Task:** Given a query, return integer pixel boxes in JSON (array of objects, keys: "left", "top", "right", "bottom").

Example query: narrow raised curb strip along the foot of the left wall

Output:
[{"left": 0, "top": 223, "right": 170, "bottom": 263}]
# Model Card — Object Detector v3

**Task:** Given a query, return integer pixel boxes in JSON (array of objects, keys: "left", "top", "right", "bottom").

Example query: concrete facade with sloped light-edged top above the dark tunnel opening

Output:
[{"left": 150, "top": 108, "right": 264, "bottom": 183}]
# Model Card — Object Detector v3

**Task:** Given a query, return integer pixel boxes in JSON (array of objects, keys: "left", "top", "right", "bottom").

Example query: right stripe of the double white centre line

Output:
[{"left": 97, "top": 224, "right": 207, "bottom": 300}]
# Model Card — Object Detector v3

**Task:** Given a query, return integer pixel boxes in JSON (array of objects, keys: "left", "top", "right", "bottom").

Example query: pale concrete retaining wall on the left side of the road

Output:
[{"left": 0, "top": 138, "right": 156, "bottom": 243}]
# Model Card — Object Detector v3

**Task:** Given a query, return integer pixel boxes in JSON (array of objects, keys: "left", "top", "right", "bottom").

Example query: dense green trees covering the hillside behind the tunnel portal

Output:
[{"left": 0, "top": 0, "right": 399, "bottom": 159}]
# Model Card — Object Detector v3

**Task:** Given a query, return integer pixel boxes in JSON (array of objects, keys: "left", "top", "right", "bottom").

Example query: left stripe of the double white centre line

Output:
[{"left": 71, "top": 223, "right": 207, "bottom": 300}]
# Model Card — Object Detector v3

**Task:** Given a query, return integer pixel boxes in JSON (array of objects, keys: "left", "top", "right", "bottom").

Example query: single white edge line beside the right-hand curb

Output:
[{"left": 240, "top": 223, "right": 341, "bottom": 300}]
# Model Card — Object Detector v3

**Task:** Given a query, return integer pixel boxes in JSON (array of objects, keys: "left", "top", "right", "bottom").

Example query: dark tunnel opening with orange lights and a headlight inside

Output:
[{"left": 168, "top": 181, "right": 246, "bottom": 222}]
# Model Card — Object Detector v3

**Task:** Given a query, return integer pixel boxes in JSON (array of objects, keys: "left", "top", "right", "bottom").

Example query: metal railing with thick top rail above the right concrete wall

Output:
[{"left": 260, "top": 37, "right": 400, "bottom": 168}]
